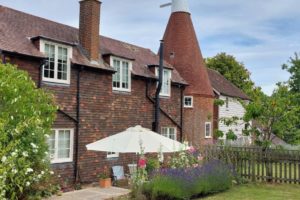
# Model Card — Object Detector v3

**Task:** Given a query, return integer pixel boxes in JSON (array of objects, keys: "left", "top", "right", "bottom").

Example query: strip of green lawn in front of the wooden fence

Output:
[{"left": 200, "top": 184, "right": 300, "bottom": 200}]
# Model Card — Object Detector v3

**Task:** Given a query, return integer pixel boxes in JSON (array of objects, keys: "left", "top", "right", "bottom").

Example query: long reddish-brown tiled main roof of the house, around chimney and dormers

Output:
[{"left": 0, "top": 5, "right": 187, "bottom": 84}]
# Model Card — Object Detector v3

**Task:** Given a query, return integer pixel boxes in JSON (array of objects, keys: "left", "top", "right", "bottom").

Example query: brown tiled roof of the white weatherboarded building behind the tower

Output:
[{"left": 207, "top": 69, "right": 250, "bottom": 100}]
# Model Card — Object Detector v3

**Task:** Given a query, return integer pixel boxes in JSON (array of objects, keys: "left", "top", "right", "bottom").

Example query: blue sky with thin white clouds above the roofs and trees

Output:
[{"left": 0, "top": 0, "right": 300, "bottom": 94}]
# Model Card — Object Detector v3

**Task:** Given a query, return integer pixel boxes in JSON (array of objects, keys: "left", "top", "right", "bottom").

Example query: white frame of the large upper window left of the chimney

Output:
[{"left": 40, "top": 40, "right": 73, "bottom": 84}]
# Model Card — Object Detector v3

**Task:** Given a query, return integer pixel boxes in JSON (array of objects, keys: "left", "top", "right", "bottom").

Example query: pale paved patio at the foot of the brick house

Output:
[{"left": 47, "top": 187, "right": 130, "bottom": 200}]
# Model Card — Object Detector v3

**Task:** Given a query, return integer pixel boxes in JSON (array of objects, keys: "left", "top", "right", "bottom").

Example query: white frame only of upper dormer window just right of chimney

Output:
[{"left": 110, "top": 56, "right": 132, "bottom": 92}]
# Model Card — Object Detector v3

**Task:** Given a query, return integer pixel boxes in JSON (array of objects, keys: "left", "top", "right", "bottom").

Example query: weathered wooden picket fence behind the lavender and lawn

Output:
[{"left": 201, "top": 146, "right": 300, "bottom": 184}]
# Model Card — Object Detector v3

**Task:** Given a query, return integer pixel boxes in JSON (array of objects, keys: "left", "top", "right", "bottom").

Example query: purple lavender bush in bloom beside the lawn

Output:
[{"left": 142, "top": 160, "right": 233, "bottom": 199}]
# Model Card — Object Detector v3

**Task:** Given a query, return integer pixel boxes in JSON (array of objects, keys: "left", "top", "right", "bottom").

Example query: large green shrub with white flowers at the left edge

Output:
[{"left": 0, "top": 63, "right": 57, "bottom": 199}]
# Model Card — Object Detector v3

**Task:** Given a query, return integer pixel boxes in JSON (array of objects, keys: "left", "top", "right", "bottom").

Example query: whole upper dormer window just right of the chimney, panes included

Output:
[{"left": 110, "top": 56, "right": 132, "bottom": 92}]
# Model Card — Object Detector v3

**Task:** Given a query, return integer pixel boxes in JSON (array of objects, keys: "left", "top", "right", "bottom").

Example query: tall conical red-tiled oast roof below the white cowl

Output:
[{"left": 164, "top": 11, "right": 213, "bottom": 97}]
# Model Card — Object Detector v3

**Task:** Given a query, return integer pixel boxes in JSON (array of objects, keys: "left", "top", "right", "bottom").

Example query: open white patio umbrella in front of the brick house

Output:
[{"left": 86, "top": 126, "right": 187, "bottom": 153}]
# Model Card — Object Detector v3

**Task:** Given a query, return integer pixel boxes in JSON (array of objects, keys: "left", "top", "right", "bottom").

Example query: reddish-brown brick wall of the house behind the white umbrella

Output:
[{"left": 7, "top": 54, "right": 181, "bottom": 183}]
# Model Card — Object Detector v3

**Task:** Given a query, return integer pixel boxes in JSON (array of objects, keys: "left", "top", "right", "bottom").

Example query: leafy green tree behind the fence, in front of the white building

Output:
[{"left": 244, "top": 84, "right": 300, "bottom": 147}]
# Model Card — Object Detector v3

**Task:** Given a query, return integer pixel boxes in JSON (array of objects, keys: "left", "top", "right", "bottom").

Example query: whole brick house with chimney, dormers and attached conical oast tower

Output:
[{"left": 0, "top": 0, "right": 248, "bottom": 183}]
